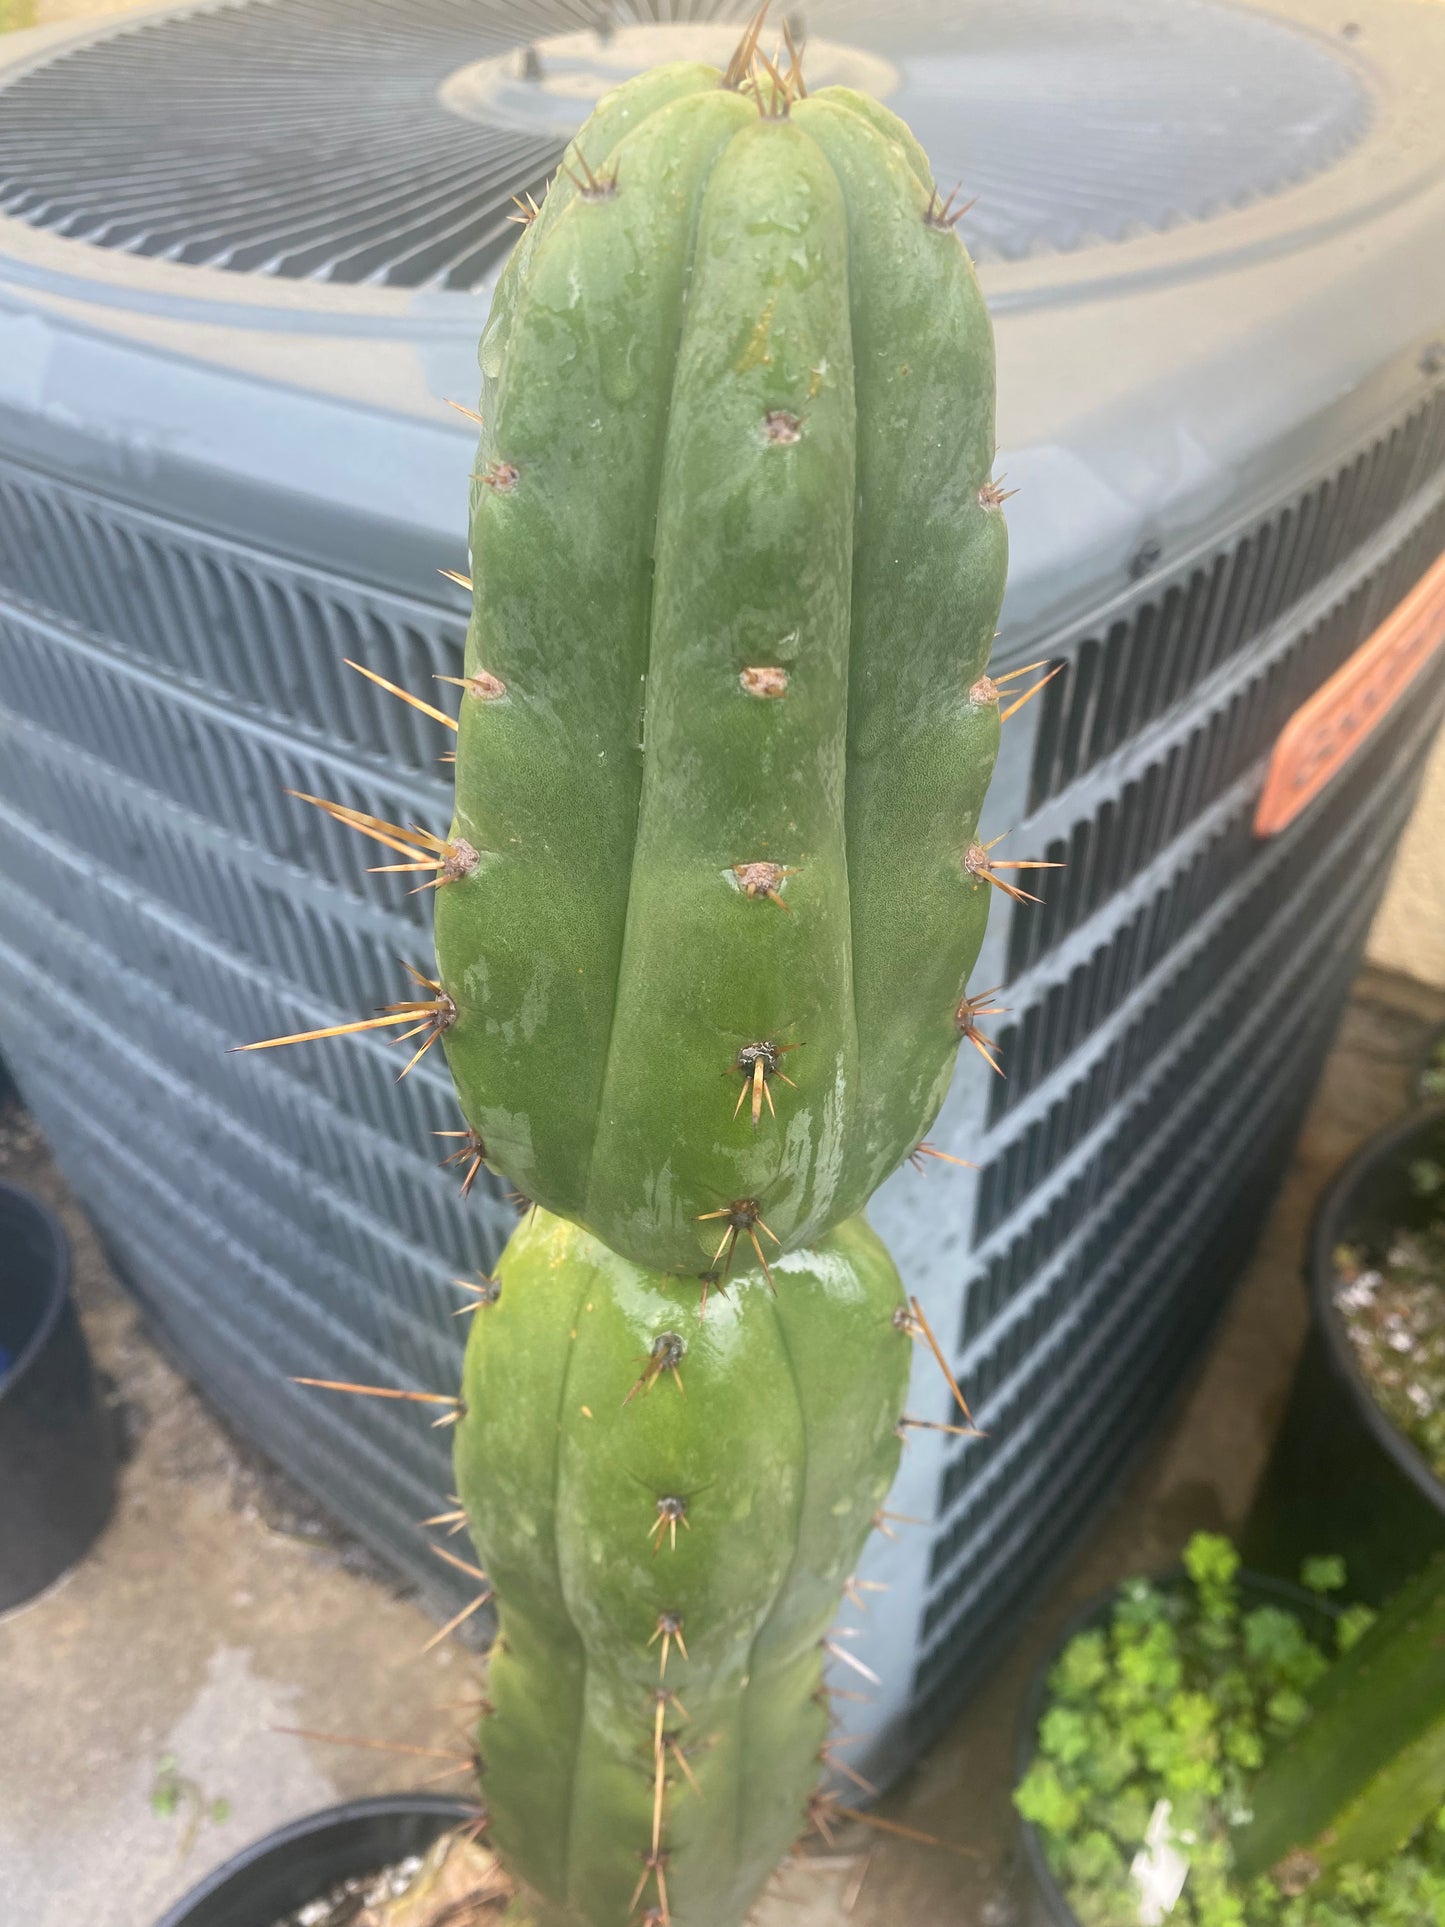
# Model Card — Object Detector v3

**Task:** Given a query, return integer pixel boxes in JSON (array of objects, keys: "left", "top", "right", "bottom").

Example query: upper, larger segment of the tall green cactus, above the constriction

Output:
[{"left": 437, "top": 66, "right": 1006, "bottom": 1274}]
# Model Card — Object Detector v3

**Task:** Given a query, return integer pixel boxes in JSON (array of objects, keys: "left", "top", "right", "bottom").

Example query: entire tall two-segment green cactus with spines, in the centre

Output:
[{"left": 237, "top": 15, "right": 1032, "bottom": 1927}]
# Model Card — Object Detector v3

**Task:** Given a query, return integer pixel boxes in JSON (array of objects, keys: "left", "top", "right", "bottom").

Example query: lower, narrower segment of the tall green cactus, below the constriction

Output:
[{"left": 457, "top": 1212, "right": 911, "bottom": 1927}]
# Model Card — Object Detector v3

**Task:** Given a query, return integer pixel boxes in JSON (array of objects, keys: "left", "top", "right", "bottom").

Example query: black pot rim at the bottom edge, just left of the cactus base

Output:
[{"left": 156, "top": 1794, "right": 476, "bottom": 1927}]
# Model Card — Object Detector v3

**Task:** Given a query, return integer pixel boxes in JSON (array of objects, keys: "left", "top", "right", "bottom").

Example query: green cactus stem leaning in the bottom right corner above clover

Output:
[{"left": 1235, "top": 1559, "right": 1445, "bottom": 1892}]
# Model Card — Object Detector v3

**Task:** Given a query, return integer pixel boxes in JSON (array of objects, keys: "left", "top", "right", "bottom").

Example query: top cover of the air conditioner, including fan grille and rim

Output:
[{"left": 0, "top": 0, "right": 1445, "bottom": 647}]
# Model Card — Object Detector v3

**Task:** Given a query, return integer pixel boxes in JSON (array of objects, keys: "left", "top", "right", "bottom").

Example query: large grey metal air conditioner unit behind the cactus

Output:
[{"left": 0, "top": 0, "right": 1445, "bottom": 1779}]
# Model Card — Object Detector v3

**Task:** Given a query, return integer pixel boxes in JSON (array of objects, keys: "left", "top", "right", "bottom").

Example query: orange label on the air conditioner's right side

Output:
[{"left": 1254, "top": 555, "right": 1445, "bottom": 836}]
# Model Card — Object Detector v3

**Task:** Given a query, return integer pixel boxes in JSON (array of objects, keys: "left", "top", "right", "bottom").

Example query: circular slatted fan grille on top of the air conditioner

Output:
[{"left": 0, "top": 0, "right": 1370, "bottom": 289}]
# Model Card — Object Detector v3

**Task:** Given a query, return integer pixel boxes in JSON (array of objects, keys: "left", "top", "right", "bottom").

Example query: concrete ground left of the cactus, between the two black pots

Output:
[{"left": 0, "top": 1110, "right": 478, "bottom": 1927}]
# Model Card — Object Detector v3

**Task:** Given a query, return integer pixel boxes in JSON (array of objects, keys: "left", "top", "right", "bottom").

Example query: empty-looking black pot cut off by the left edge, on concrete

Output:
[{"left": 0, "top": 1183, "right": 116, "bottom": 1613}]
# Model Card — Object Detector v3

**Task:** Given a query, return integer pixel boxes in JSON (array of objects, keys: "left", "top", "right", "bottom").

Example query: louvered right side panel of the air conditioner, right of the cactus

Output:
[{"left": 884, "top": 458, "right": 1445, "bottom": 1757}]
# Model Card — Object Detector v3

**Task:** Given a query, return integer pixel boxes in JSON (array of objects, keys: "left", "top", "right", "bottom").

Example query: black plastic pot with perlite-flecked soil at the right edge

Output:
[{"left": 1241, "top": 1104, "right": 1445, "bottom": 1605}]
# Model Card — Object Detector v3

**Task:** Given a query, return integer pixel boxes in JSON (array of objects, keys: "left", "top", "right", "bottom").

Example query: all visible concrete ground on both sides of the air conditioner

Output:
[{"left": 0, "top": 973, "right": 1445, "bottom": 1927}]
